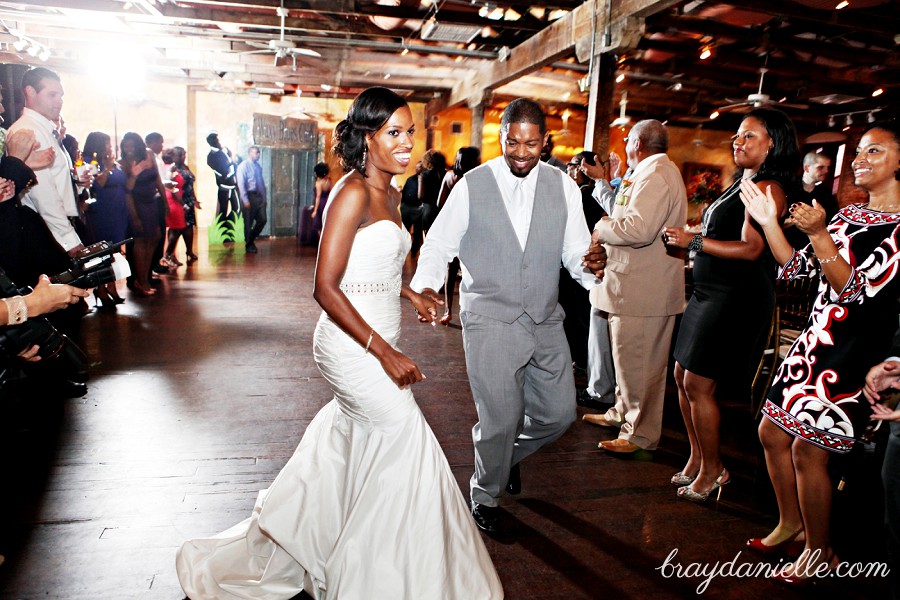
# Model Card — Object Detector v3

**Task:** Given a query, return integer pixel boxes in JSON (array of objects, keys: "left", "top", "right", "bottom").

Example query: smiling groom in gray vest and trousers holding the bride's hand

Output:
[{"left": 410, "top": 98, "right": 606, "bottom": 534}]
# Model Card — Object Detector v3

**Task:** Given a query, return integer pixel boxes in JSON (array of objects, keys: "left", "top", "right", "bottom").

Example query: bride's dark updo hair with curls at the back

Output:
[{"left": 331, "top": 87, "right": 407, "bottom": 176}]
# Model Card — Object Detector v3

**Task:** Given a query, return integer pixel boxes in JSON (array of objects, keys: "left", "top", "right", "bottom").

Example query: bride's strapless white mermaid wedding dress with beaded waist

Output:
[{"left": 176, "top": 221, "right": 503, "bottom": 600}]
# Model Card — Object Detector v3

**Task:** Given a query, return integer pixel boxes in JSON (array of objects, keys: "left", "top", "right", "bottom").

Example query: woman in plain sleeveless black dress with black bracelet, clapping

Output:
[{"left": 664, "top": 108, "right": 800, "bottom": 502}]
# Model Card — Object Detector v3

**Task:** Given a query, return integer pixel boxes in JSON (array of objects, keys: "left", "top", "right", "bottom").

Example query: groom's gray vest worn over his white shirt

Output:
[{"left": 459, "top": 164, "right": 568, "bottom": 323}]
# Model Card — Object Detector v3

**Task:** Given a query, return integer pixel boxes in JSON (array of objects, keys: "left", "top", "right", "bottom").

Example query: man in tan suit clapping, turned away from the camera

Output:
[{"left": 584, "top": 119, "right": 687, "bottom": 454}]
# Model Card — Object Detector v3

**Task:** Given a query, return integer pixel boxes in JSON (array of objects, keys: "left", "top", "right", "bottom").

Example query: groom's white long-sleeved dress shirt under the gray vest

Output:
[{"left": 410, "top": 156, "right": 597, "bottom": 292}]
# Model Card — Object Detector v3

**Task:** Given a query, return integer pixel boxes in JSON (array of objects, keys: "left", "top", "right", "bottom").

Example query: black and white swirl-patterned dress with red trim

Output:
[{"left": 763, "top": 205, "right": 900, "bottom": 454}]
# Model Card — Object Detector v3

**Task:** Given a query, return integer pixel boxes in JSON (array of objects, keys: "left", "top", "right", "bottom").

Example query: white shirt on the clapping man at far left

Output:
[{"left": 9, "top": 108, "right": 81, "bottom": 252}]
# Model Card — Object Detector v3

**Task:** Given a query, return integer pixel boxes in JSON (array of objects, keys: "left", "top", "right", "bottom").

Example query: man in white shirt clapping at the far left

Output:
[{"left": 9, "top": 67, "right": 84, "bottom": 256}]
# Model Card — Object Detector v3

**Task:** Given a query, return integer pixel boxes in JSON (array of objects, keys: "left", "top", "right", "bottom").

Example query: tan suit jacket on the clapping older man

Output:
[{"left": 590, "top": 154, "right": 687, "bottom": 317}]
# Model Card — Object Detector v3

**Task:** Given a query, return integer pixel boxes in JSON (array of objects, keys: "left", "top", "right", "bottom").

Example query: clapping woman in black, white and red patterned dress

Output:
[{"left": 741, "top": 124, "right": 900, "bottom": 585}]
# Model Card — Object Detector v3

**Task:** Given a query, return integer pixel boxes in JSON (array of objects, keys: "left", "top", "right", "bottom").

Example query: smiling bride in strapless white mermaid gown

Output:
[{"left": 176, "top": 88, "right": 503, "bottom": 600}]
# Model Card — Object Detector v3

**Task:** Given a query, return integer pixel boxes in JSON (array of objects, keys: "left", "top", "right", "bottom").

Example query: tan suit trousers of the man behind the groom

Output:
[{"left": 604, "top": 314, "right": 675, "bottom": 450}]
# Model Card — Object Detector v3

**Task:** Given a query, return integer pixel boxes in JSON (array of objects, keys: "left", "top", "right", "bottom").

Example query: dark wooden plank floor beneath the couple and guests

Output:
[{"left": 0, "top": 239, "right": 886, "bottom": 600}]
